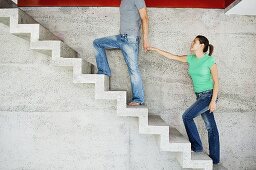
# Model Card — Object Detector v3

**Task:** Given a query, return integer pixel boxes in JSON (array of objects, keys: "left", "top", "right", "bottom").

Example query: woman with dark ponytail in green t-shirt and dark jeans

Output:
[{"left": 149, "top": 35, "right": 220, "bottom": 164}]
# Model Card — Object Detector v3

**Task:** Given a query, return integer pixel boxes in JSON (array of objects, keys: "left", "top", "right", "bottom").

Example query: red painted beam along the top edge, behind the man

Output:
[{"left": 18, "top": 0, "right": 234, "bottom": 8}]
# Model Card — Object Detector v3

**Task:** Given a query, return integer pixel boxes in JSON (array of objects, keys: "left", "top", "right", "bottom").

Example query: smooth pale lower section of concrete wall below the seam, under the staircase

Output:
[{"left": 0, "top": 109, "right": 181, "bottom": 170}]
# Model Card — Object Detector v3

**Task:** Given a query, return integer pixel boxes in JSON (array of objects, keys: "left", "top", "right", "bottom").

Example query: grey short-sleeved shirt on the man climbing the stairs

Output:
[{"left": 120, "top": 0, "right": 146, "bottom": 36}]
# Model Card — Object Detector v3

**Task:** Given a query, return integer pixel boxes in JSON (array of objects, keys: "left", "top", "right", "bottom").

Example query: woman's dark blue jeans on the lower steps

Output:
[{"left": 182, "top": 90, "right": 220, "bottom": 164}]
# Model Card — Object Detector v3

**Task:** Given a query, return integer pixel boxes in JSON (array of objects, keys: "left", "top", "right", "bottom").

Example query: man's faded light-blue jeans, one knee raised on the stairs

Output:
[{"left": 93, "top": 34, "right": 144, "bottom": 103}]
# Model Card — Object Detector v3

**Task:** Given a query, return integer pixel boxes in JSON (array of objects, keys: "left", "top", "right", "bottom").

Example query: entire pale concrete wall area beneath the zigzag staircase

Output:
[{"left": 0, "top": 20, "right": 181, "bottom": 170}]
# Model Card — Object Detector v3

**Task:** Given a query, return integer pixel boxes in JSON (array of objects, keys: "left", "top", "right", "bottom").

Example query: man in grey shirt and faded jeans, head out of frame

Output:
[{"left": 93, "top": 0, "right": 149, "bottom": 106}]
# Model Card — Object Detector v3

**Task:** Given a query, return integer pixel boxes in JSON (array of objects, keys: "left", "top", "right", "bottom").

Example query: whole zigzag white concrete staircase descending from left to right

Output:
[{"left": 0, "top": 8, "right": 213, "bottom": 170}]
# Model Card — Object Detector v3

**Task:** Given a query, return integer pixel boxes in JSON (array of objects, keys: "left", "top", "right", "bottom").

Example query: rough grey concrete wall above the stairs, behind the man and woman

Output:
[{"left": 19, "top": 8, "right": 256, "bottom": 169}]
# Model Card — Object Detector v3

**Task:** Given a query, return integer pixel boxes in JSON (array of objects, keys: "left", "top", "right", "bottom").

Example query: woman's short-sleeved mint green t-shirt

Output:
[{"left": 187, "top": 54, "right": 215, "bottom": 93}]
